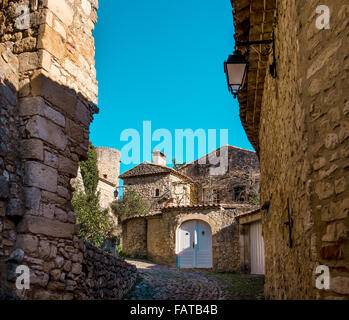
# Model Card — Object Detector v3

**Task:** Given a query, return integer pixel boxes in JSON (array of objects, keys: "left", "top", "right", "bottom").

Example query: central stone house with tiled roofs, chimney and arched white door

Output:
[{"left": 120, "top": 146, "right": 258, "bottom": 271}]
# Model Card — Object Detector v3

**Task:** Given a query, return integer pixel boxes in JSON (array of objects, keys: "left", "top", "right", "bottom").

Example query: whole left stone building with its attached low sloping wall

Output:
[{"left": 0, "top": 0, "right": 135, "bottom": 299}]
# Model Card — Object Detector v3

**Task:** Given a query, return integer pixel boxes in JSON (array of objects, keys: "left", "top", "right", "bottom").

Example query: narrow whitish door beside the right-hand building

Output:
[{"left": 250, "top": 221, "right": 264, "bottom": 274}]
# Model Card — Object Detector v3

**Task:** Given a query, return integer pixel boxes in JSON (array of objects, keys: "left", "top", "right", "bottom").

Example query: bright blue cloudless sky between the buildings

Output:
[{"left": 91, "top": 0, "right": 253, "bottom": 172}]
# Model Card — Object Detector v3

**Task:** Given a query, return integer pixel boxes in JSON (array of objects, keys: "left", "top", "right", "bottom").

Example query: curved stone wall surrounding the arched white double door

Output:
[{"left": 122, "top": 207, "right": 240, "bottom": 271}]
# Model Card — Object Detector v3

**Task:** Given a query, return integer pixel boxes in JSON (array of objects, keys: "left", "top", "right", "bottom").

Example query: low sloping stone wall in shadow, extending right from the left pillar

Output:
[{"left": 82, "top": 244, "right": 137, "bottom": 300}]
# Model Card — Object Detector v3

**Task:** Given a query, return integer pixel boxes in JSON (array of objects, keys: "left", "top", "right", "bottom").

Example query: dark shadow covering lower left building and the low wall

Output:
[{"left": 0, "top": 72, "right": 135, "bottom": 299}]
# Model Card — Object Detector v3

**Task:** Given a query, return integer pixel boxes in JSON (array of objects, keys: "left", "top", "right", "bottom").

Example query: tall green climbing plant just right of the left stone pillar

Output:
[{"left": 72, "top": 143, "right": 114, "bottom": 247}]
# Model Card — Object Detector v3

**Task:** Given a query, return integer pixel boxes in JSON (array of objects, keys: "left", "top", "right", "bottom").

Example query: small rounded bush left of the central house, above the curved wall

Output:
[{"left": 111, "top": 190, "right": 149, "bottom": 219}]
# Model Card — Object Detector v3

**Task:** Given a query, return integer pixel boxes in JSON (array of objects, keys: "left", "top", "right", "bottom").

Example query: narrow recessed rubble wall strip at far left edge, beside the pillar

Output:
[{"left": 0, "top": 44, "right": 23, "bottom": 287}]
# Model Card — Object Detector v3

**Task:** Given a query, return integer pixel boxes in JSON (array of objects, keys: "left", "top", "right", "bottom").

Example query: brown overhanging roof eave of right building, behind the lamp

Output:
[{"left": 231, "top": 0, "right": 276, "bottom": 154}]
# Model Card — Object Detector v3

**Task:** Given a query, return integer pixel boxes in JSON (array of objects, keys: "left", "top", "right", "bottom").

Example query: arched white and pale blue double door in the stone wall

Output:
[{"left": 176, "top": 220, "right": 212, "bottom": 268}]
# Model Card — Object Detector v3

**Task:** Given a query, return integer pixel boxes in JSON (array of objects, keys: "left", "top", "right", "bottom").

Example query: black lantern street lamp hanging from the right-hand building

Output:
[{"left": 224, "top": 51, "right": 248, "bottom": 98}]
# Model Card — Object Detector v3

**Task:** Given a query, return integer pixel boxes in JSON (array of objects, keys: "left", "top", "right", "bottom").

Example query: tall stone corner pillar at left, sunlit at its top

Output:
[{"left": 0, "top": 0, "right": 98, "bottom": 299}]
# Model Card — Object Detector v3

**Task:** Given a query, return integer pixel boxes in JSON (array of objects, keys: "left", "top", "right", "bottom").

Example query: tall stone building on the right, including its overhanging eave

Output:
[{"left": 232, "top": 0, "right": 349, "bottom": 299}]
